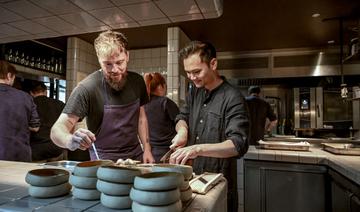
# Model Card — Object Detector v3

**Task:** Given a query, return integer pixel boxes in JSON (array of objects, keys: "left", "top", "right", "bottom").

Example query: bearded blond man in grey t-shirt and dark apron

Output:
[{"left": 51, "top": 31, "right": 154, "bottom": 162}]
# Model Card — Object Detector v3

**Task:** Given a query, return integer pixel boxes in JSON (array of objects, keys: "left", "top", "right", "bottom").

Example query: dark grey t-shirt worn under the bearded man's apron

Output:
[{"left": 63, "top": 70, "right": 149, "bottom": 133}]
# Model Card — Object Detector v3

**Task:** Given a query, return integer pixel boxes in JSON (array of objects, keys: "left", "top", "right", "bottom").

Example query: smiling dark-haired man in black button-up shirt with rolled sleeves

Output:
[{"left": 170, "top": 41, "right": 249, "bottom": 211}]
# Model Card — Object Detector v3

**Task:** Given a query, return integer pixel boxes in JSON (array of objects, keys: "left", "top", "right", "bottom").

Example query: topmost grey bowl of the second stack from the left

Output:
[{"left": 73, "top": 160, "right": 114, "bottom": 177}]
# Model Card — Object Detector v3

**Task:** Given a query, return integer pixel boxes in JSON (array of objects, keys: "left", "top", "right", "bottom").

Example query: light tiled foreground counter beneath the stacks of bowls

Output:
[{"left": 0, "top": 160, "right": 227, "bottom": 212}]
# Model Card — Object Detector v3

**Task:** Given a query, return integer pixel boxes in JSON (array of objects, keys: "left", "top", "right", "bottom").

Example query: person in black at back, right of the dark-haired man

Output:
[{"left": 245, "top": 86, "right": 277, "bottom": 145}]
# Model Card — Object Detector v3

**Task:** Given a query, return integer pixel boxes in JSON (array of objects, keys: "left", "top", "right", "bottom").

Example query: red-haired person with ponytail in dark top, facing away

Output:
[{"left": 144, "top": 72, "right": 179, "bottom": 162}]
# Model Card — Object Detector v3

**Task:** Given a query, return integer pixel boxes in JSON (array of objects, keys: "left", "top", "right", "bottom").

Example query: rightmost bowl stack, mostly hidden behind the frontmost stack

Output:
[{"left": 152, "top": 164, "right": 193, "bottom": 202}]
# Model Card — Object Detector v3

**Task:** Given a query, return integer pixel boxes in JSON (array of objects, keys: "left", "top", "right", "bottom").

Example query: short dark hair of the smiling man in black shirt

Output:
[{"left": 179, "top": 41, "right": 216, "bottom": 65}]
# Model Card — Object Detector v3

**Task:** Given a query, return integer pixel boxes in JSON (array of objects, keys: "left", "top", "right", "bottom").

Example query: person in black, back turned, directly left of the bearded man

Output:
[{"left": 30, "top": 81, "right": 65, "bottom": 162}]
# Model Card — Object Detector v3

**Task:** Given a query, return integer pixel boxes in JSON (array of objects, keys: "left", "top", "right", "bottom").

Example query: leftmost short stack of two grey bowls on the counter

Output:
[{"left": 25, "top": 168, "right": 71, "bottom": 198}]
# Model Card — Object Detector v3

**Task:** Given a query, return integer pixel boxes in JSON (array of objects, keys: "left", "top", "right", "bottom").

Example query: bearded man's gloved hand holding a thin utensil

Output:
[{"left": 67, "top": 128, "right": 96, "bottom": 151}]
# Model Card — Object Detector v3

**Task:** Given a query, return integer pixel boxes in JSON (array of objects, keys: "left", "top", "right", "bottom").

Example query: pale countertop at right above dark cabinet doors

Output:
[{"left": 244, "top": 146, "right": 360, "bottom": 185}]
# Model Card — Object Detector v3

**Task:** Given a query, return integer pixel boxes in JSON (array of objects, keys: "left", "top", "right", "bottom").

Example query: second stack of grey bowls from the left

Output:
[{"left": 69, "top": 160, "right": 113, "bottom": 200}]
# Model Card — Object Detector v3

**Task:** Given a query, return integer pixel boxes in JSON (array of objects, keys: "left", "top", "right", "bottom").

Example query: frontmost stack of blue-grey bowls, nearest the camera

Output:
[{"left": 130, "top": 172, "right": 184, "bottom": 212}]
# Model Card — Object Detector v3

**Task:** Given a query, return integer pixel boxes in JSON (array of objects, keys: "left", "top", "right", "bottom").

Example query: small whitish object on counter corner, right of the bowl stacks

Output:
[{"left": 190, "top": 172, "right": 223, "bottom": 194}]
